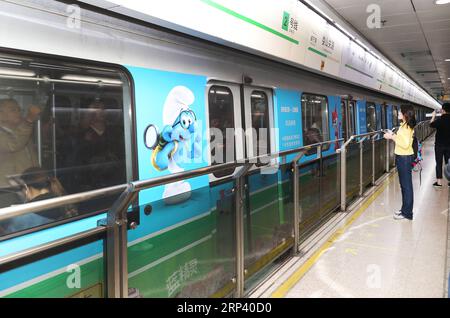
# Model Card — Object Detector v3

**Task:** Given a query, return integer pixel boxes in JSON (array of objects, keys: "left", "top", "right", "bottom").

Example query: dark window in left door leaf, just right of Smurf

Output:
[{"left": 208, "top": 86, "right": 236, "bottom": 178}]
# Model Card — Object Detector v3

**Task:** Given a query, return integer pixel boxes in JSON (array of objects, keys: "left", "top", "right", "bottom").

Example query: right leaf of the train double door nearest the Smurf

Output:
[{"left": 242, "top": 86, "right": 287, "bottom": 287}]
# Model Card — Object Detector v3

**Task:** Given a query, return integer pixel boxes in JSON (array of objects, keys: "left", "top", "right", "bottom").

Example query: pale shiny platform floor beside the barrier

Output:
[{"left": 270, "top": 137, "right": 449, "bottom": 298}]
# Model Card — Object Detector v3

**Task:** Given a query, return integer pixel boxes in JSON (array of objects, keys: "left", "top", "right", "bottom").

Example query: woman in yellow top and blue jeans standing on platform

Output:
[{"left": 384, "top": 105, "right": 416, "bottom": 220}]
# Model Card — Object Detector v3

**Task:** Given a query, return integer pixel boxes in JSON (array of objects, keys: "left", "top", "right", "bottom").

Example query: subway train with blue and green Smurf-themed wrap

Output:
[{"left": 0, "top": 1, "right": 433, "bottom": 297}]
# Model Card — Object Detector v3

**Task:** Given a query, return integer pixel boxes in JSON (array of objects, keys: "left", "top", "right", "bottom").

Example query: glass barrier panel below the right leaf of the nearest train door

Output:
[{"left": 244, "top": 164, "right": 294, "bottom": 290}]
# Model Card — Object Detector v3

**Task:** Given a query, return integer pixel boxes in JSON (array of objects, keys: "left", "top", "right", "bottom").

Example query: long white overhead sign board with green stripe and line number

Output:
[{"left": 88, "top": 0, "right": 439, "bottom": 108}]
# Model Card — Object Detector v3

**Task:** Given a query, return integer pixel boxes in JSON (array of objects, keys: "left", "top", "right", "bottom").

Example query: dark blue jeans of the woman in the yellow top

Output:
[{"left": 395, "top": 155, "right": 414, "bottom": 220}]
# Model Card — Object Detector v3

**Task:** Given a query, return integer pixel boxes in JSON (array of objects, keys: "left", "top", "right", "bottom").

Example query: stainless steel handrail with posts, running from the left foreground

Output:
[{"left": 0, "top": 139, "right": 343, "bottom": 297}]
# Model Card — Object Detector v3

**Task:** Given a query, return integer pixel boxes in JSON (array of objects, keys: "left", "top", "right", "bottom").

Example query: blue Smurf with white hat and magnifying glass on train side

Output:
[{"left": 144, "top": 86, "right": 201, "bottom": 204}]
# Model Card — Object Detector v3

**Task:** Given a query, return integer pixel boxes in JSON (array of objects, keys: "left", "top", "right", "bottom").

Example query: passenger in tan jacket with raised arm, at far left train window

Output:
[{"left": 0, "top": 99, "right": 41, "bottom": 208}]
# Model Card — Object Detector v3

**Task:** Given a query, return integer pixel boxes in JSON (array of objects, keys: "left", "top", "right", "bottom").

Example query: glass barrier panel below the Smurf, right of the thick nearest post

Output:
[{"left": 128, "top": 179, "right": 236, "bottom": 298}]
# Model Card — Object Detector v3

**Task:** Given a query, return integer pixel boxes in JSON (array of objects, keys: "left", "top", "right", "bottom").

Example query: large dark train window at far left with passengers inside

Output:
[{"left": 0, "top": 55, "right": 130, "bottom": 236}]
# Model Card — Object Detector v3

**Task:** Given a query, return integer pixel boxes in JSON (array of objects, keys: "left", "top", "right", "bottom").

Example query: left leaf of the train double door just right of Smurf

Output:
[{"left": 206, "top": 82, "right": 244, "bottom": 275}]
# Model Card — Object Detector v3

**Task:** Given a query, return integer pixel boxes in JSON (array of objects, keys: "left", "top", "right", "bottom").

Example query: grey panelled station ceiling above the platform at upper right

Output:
[{"left": 323, "top": 0, "right": 450, "bottom": 100}]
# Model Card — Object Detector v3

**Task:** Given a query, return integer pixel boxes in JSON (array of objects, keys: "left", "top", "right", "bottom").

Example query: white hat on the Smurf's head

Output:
[{"left": 163, "top": 86, "right": 195, "bottom": 125}]
